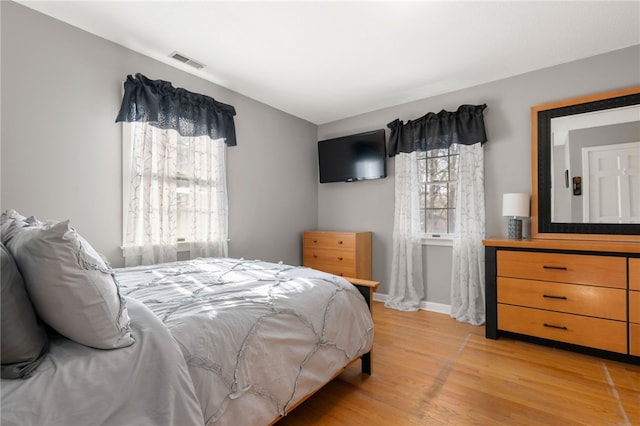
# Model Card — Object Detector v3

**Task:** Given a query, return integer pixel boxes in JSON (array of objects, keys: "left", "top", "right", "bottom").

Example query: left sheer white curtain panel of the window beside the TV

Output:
[{"left": 384, "top": 151, "right": 424, "bottom": 311}]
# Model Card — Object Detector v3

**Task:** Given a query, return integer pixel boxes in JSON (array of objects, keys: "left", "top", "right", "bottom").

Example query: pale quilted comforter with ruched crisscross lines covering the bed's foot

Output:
[{"left": 115, "top": 258, "right": 373, "bottom": 425}]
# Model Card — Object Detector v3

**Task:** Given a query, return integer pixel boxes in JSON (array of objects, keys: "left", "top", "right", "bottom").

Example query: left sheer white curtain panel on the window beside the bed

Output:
[{"left": 123, "top": 122, "right": 178, "bottom": 266}]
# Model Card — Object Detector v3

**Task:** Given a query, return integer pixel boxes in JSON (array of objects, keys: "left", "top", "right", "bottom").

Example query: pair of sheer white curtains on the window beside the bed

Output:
[{"left": 123, "top": 122, "right": 228, "bottom": 266}]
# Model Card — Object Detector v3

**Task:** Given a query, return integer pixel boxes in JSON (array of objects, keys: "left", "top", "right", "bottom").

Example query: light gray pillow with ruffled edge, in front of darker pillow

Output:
[{"left": 7, "top": 221, "right": 134, "bottom": 349}]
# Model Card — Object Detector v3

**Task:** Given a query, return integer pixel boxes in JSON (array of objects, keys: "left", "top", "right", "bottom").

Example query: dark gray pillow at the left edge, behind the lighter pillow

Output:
[{"left": 0, "top": 243, "right": 48, "bottom": 379}]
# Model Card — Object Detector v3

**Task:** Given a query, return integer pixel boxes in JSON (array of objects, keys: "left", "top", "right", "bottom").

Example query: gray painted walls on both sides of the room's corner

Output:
[{"left": 0, "top": 2, "right": 640, "bottom": 304}]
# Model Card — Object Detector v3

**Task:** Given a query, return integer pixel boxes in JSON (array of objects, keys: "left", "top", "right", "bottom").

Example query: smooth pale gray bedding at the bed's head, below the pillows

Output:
[{"left": 0, "top": 299, "right": 204, "bottom": 426}]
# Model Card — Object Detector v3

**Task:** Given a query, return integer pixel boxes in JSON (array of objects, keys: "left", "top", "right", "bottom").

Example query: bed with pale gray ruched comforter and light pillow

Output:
[{"left": 0, "top": 211, "right": 373, "bottom": 426}]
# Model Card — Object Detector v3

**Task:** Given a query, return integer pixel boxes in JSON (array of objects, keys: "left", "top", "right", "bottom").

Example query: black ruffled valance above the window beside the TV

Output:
[{"left": 387, "top": 104, "right": 487, "bottom": 157}]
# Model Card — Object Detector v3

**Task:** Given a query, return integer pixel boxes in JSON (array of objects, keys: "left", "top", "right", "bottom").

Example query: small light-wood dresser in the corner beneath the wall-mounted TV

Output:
[{"left": 302, "top": 231, "right": 371, "bottom": 280}]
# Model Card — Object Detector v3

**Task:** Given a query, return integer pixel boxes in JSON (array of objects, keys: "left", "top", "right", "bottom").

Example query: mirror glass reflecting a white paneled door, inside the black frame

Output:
[{"left": 550, "top": 105, "right": 640, "bottom": 224}]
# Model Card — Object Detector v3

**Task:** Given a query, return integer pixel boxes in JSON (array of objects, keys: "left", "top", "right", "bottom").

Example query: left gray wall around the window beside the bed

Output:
[{"left": 0, "top": 1, "right": 317, "bottom": 266}]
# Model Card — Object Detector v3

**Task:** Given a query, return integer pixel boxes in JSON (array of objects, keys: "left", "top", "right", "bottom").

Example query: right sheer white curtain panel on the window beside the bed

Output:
[{"left": 187, "top": 136, "right": 229, "bottom": 257}]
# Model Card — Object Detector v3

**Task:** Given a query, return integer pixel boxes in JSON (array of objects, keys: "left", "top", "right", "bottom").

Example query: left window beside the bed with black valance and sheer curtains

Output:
[{"left": 116, "top": 74, "right": 236, "bottom": 266}]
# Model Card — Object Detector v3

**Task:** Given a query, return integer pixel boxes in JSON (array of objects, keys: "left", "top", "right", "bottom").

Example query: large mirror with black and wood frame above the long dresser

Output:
[{"left": 531, "top": 86, "right": 640, "bottom": 241}]
